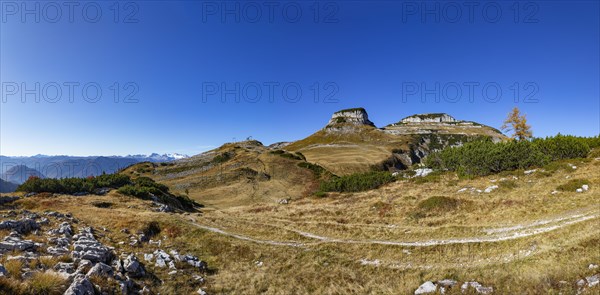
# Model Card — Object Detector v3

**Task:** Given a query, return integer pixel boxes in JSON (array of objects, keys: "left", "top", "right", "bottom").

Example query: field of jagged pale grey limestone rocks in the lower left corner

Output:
[{"left": 0, "top": 210, "right": 207, "bottom": 295}]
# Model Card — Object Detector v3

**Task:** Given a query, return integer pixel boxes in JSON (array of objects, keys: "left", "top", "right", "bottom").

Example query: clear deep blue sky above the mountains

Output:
[{"left": 0, "top": 1, "right": 600, "bottom": 155}]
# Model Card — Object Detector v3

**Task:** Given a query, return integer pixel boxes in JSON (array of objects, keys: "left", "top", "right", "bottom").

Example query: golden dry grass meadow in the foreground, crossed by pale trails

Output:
[{"left": 3, "top": 155, "right": 600, "bottom": 294}]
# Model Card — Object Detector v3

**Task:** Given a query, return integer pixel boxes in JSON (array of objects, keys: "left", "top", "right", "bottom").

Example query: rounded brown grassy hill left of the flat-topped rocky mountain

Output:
[{"left": 123, "top": 142, "right": 317, "bottom": 208}]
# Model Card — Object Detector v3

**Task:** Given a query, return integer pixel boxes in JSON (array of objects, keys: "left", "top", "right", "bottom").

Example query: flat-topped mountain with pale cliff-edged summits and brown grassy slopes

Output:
[{"left": 284, "top": 108, "right": 506, "bottom": 175}]
